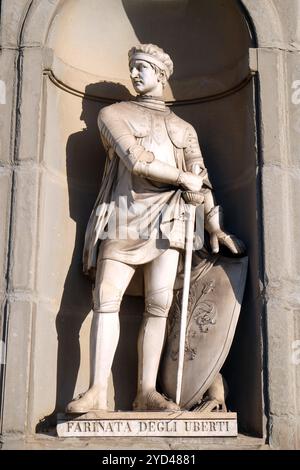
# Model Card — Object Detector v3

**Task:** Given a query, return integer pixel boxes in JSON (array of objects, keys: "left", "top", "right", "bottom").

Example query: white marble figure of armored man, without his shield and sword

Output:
[{"left": 66, "top": 44, "right": 244, "bottom": 413}]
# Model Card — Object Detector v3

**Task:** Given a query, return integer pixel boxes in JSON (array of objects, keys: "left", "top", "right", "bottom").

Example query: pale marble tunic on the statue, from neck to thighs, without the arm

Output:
[{"left": 83, "top": 100, "right": 210, "bottom": 272}]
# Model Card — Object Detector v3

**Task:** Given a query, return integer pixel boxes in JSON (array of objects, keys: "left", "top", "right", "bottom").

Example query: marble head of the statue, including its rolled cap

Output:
[{"left": 128, "top": 44, "right": 173, "bottom": 95}]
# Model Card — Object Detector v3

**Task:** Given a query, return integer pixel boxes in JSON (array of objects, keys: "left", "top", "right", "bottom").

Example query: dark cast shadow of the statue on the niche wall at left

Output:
[{"left": 36, "top": 82, "right": 132, "bottom": 432}]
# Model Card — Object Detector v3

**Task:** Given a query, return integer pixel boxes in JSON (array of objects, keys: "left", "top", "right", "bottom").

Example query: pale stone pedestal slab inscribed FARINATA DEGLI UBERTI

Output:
[{"left": 57, "top": 411, "right": 237, "bottom": 437}]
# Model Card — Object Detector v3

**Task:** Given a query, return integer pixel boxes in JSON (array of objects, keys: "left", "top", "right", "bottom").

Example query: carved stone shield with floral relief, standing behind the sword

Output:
[{"left": 160, "top": 257, "right": 248, "bottom": 409}]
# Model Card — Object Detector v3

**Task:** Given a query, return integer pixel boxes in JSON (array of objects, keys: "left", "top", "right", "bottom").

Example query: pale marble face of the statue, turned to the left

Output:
[{"left": 130, "top": 60, "right": 159, "bottom": 95}]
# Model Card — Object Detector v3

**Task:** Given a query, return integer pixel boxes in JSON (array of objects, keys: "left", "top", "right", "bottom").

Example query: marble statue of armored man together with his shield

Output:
[{"left": 66, "top": 44, "right": 246, "bottom": 413}]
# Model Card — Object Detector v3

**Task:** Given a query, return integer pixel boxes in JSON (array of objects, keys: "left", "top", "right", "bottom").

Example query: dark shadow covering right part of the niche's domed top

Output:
[{"left": 122, "top": 0, "right": 251, "bottom": 99}]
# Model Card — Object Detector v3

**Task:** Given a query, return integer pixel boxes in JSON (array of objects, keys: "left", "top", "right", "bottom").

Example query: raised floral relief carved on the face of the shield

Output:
[{"left": 168, "top": 280, "right": 217, "bottom": 361}]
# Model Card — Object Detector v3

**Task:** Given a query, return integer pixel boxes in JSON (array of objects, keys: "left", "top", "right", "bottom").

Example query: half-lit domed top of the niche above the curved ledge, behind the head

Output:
[{"left": 42, "top": 0, "right": 252, "bottom": 101}]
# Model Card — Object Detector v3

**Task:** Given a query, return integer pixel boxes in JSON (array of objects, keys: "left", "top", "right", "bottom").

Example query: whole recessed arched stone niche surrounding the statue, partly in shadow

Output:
[{"left": 31, "top": 0, "right": 262, "bottom": 435}]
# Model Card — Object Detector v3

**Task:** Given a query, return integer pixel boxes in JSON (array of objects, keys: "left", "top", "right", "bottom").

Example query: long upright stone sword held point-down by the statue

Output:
[{"left": 176, "top": 186, "right": 204, "bottom": 405}]
